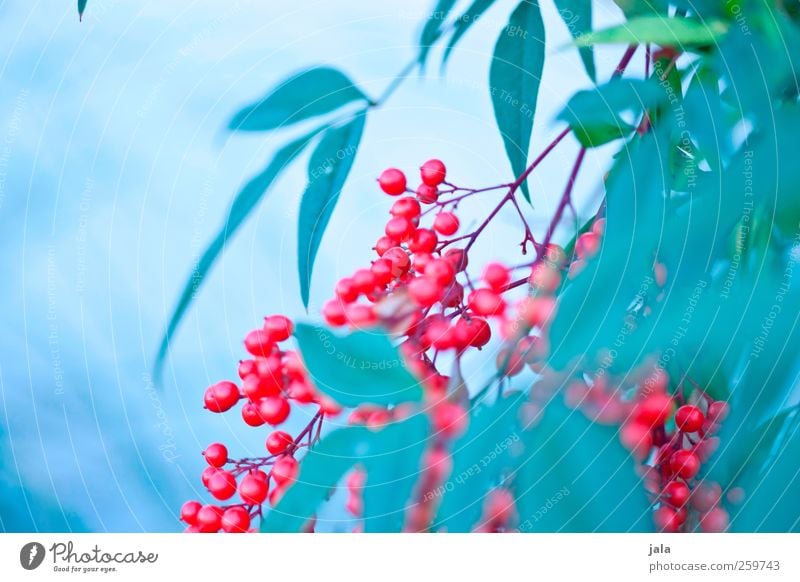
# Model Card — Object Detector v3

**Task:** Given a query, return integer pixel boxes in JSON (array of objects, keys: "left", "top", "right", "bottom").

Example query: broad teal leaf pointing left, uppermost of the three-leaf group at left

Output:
[{"left": 228, "top": 67, "right": 369, "bottom": 131}]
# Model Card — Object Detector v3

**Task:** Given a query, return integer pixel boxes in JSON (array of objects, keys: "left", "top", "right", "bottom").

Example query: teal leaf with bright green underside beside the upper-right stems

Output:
[{"left": 559, "top": 79, "right": 667, "bottom": 148}]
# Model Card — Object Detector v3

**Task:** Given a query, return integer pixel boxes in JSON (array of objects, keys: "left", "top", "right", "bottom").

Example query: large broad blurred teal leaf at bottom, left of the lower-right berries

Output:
[{"left": 514, "top": 400, "right": 652, "bottom": 532}]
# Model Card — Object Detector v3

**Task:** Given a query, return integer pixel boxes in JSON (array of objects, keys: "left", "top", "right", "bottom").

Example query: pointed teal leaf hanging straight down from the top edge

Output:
[{"left": 489, "top": 0, "right": 545, "bottom": 201}]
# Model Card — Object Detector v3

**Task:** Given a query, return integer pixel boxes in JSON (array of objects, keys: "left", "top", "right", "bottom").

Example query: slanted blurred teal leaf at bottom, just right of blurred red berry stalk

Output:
[{"left": 432, "top": 395, "right": 525, "bottom": 533}]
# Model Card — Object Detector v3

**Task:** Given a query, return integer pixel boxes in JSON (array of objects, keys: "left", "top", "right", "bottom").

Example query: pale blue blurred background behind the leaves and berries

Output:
[{"left": 0, "top": 0, "right": 635, "bottom": 531}]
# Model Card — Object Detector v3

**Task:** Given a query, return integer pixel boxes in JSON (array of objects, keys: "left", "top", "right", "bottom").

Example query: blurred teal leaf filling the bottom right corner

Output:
[{"left": 730, "top": 417, "right": 800, "bottom": 533}]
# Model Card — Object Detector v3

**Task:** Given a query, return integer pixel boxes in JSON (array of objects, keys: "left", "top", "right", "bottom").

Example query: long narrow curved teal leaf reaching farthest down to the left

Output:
[{"left": 154, "top": 128, "right": 322, "bottom": 377}]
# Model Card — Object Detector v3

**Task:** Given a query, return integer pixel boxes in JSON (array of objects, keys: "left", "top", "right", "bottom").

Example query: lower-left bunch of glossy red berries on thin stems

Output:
[{"left": 181, "top": 315, "right": 334, "bottom": 533}]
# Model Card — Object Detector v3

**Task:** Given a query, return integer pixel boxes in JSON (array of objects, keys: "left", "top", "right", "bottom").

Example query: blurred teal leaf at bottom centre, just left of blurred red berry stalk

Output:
[{"left": 363, "top": 414, "right": 430, "bottom": 533}]
